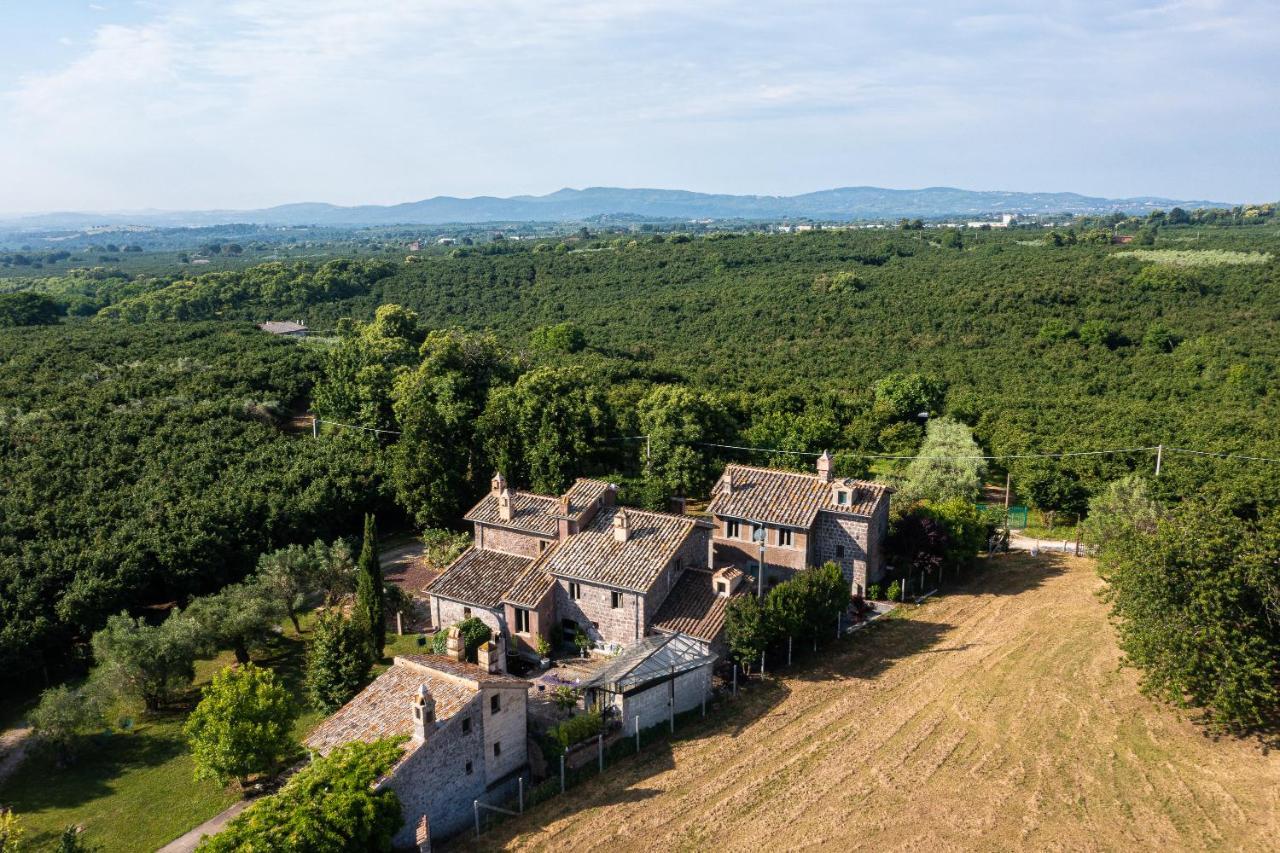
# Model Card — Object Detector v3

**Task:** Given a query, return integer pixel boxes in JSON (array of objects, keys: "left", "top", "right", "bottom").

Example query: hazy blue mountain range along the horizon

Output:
[{"left": 4, "top": 187, "right": 1230, "bottom": 228}]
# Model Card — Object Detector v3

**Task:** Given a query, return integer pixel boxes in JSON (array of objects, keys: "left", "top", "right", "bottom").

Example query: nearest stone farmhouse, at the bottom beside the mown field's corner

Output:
[{"left": 305, "top": 629, "right": 530, "bottom": 849}]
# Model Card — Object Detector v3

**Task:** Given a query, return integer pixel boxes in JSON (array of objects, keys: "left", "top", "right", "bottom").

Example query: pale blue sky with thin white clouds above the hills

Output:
[{"left": 0, "top": 0, "right": 1280, "bottom": 213}]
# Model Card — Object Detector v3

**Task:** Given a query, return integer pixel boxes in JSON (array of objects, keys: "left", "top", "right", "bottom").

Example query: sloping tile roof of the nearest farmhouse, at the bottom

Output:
[{"left": 303, "top": 658, "right": 480, "bottom": 753}]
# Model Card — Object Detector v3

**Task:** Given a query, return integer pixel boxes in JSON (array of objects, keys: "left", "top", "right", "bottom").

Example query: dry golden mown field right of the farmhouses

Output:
[{"left": 463, "top": 556, "right": 1280, "bottom": 850}]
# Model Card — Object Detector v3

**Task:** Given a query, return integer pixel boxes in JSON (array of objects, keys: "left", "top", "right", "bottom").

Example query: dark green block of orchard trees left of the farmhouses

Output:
[{"left": 0, "top": 323, "right": 380, "bottom": 676}]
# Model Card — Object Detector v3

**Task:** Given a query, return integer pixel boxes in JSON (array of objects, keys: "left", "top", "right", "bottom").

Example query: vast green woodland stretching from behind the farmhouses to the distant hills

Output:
[{"left": 0, "top": 218, "right": 1280, "bottom": 696}]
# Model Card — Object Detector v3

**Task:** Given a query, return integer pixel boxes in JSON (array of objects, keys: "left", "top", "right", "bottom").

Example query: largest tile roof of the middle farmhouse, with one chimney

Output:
[{"left": 543, "top": 506, "right": 696, "bottom": 592}]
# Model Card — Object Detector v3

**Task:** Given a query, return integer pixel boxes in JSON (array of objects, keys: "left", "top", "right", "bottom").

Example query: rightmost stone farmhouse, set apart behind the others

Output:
[{"left": 708, "top": 453, "right": 891, "bottom": 596}]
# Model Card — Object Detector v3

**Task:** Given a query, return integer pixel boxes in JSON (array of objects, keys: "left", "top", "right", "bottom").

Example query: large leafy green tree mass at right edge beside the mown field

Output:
[{"left": 1094, "top": 496, "right": 1280, "bottom": 731}]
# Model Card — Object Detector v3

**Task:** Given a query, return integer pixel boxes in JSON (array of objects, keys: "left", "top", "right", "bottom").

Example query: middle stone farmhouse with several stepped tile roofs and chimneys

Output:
[{"left": 425, "top": 474, "right": 712, "bottom": 656}]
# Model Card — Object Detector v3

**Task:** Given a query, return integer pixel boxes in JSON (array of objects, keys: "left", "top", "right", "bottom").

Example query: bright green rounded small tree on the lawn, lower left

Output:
[{"left": 186, "top": 663, "right": 297, "bottom": 788}]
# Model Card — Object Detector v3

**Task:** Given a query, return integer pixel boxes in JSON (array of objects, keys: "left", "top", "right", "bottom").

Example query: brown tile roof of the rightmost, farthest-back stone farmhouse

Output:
[{"left": 707, "top": 465, "right": 890, "bottom": 529}]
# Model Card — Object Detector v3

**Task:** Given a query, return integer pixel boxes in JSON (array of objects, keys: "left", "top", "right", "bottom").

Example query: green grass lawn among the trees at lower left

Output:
[{"left": 0, "top": 619, "right": 425, "bottom": 853}]
